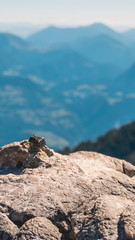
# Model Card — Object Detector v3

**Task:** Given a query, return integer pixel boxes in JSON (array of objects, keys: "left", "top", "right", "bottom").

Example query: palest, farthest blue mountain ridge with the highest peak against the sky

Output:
[{"left": 27, "top": 23, "right": 120, "bottom": 48}]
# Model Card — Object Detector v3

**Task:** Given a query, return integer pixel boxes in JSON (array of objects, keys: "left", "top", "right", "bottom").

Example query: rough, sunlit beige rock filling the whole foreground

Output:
[{"left": 0, "top": 138, "right": 135, "bottom": 240}]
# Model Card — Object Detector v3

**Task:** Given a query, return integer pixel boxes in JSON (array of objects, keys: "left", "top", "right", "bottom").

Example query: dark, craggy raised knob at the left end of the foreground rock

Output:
[{"left": 0, "top": 136, "right": 54, "bottom": 172}]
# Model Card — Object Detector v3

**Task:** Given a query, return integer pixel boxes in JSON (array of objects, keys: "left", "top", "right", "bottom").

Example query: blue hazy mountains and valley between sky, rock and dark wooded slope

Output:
[{"left": 0, "top": 23, "right": 135, "bottom": 149}]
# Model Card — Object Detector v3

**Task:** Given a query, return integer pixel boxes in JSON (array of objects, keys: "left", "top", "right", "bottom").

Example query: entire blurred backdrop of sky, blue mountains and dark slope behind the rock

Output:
[{"left": 0, "top": 0, "right": 135, "bottom": 164}]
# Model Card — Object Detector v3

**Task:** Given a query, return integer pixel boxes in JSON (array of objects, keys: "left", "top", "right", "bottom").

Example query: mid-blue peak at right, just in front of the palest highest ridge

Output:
[{"left": 71, "top": 34, "right": 135, "bottom": 69}]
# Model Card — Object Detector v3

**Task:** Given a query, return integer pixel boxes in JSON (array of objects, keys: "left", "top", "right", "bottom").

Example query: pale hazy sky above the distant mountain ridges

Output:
[{"left": 0, "top": 0, "right": 135, "bottom": 27}]
